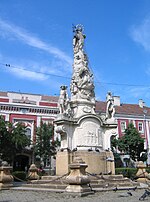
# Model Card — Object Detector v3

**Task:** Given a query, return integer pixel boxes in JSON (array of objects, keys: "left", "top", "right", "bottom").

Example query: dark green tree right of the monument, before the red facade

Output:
[{"left": 118, "top": 123, "right": 145, "bottom": 161}]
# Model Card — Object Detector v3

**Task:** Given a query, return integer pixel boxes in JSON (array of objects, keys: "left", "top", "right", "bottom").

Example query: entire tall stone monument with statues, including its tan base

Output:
[{"left": 55, "top": 25, "right": 117, "bottom": 175}]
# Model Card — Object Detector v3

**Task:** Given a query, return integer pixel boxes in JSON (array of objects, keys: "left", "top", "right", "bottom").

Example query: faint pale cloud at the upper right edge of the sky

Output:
[{"left": 131, "top": 16, "right": 150, "bottom": 51}]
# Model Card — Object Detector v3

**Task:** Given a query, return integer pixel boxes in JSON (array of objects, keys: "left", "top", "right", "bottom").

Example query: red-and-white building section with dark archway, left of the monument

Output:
[{"left": 0, "top": 92, "right": 59, "bottom": 169}]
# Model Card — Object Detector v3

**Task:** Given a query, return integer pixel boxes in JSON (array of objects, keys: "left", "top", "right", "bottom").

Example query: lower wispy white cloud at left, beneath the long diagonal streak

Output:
[{"left": 0, "top": 54, "right": 65, "bottom": 81}]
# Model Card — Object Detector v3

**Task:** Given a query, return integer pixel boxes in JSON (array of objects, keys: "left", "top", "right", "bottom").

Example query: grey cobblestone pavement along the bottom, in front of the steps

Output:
[{"left": 0, "top": 189, "right": 150, "bottom": 202}]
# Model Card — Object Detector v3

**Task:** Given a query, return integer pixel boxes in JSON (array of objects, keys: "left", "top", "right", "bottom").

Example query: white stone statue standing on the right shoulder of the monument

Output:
[{"left": 106, "top": 92, "right": 115, "bottom": 120}]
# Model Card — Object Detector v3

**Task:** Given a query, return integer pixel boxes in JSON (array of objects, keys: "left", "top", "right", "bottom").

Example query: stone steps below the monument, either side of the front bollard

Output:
[{"left": 11, "top": 175, "right": 138, "bottom": 192}]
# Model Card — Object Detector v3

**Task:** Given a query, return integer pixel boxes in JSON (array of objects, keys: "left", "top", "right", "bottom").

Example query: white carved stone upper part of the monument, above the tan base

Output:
[{"left": 55, "top": 25, "right": 117, "bottom": 150}]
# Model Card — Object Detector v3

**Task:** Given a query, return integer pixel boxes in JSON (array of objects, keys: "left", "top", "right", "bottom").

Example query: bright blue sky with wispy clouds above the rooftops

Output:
[{"left": 0, "top": 0, "right": 150, "bottom": 106}]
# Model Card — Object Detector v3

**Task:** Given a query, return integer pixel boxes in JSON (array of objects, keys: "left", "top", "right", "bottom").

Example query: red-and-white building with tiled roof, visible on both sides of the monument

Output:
[{"left": 0, "top": 92, "right": 150, "bottom": 167}]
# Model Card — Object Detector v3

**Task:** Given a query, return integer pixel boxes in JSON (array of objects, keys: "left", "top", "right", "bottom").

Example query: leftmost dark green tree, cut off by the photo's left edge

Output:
[{"left": 0, "top": 116, "right": 31, "bottom": 163}]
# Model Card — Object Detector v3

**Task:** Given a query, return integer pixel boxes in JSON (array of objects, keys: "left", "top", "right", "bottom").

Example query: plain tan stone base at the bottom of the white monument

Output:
[{"left": 56, "top": 150, "right": 115, "bottom": 176}]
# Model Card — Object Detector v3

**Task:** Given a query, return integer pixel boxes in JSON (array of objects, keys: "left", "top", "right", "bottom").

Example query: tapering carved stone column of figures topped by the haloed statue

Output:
[{"left": 70, "top": 25, "right": 95, "bottom": 101}]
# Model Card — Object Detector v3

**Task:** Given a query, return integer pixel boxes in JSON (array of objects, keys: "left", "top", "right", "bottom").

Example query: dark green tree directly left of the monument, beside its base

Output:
[{"left": 34, "top": 122, "right": 60, "bottom": 167}]
